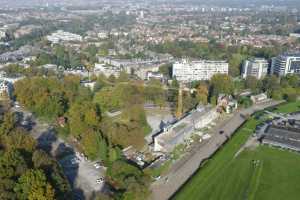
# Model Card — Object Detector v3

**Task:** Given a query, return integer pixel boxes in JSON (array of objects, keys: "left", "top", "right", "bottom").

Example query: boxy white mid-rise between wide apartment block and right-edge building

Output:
[{"left": 242, "top": 58, "right": 269, "bottom": 79}]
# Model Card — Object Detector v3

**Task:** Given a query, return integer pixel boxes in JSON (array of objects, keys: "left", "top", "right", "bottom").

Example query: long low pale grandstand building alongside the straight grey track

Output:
[{"left": 154, "top": 107, "right": 219, "bottom": 153}]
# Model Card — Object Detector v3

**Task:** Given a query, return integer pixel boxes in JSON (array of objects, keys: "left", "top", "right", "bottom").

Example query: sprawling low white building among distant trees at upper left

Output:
[{"left": 47, "top": 30, "right": 82, "bottom": 44}]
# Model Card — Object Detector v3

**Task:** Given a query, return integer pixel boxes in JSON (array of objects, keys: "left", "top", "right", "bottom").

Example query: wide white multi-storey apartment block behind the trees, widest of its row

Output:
[{"left": 173, "top": 60, "right": 228, "bottom": 82}]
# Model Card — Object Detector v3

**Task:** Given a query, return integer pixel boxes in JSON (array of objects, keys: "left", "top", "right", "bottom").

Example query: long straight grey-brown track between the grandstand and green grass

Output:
[{"left": 150, "top": 101, "right": 281, "bottom": 200}]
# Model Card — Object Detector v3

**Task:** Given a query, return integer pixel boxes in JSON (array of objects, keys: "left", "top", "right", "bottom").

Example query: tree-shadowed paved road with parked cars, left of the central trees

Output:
[{"left": 12, "top": 107, "right": 106, "bottom": 199}]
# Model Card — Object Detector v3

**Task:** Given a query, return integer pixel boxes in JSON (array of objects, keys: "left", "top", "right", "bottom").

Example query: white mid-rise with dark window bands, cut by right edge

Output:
[{"left": 271, "top": 54, "right": 300, "bottom": 76}]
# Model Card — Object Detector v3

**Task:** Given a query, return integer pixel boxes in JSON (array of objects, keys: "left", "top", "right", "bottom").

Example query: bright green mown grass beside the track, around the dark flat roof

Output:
[{"left": 173, "top": 102, "right": 300, "bottom": 200}]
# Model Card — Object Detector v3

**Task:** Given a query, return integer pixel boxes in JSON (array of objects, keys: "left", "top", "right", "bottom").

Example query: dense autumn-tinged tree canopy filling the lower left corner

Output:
[{"left": 0, "top": 112, "right": 72, "bottom": 200}]
